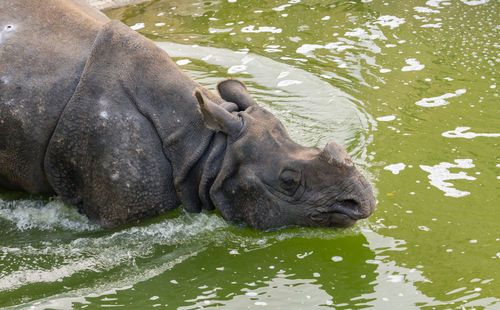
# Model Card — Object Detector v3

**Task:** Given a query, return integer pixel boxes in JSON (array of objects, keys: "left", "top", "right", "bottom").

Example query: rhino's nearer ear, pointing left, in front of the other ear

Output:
[{"left": 194, "top": 90, "right": 243, "bottom": 136}]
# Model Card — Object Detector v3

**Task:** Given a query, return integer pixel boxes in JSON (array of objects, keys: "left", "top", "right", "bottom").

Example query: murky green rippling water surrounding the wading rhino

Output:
[{"left": 0, "top": 0, "right": 500, "bottom": 309}]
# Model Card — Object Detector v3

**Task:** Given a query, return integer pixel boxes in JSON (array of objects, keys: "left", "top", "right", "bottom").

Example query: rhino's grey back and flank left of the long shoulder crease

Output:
[{"left": 0, "top": 0, "right": 109, "bottom": 193}]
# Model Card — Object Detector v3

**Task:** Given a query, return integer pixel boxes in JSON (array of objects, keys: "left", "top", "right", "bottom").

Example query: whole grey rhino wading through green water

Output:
[{"left": 0, "top": 0, "right": 375, "bottom": 229}]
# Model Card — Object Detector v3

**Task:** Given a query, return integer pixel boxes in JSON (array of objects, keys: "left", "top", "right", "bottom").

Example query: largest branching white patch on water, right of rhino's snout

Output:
[{"left": 420, "top": 159, "right": 476, "bottom": 198}]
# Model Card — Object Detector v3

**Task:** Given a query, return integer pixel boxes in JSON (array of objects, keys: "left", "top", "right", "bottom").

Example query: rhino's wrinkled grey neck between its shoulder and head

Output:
[{"left": 91, "top": 21, "right": 226, "bottom": 212}]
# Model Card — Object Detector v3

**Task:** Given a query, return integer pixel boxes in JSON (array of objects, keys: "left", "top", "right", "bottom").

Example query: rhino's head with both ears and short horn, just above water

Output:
[{"left": 195, "top": 80, "right": 375, "bottom": 229}]
